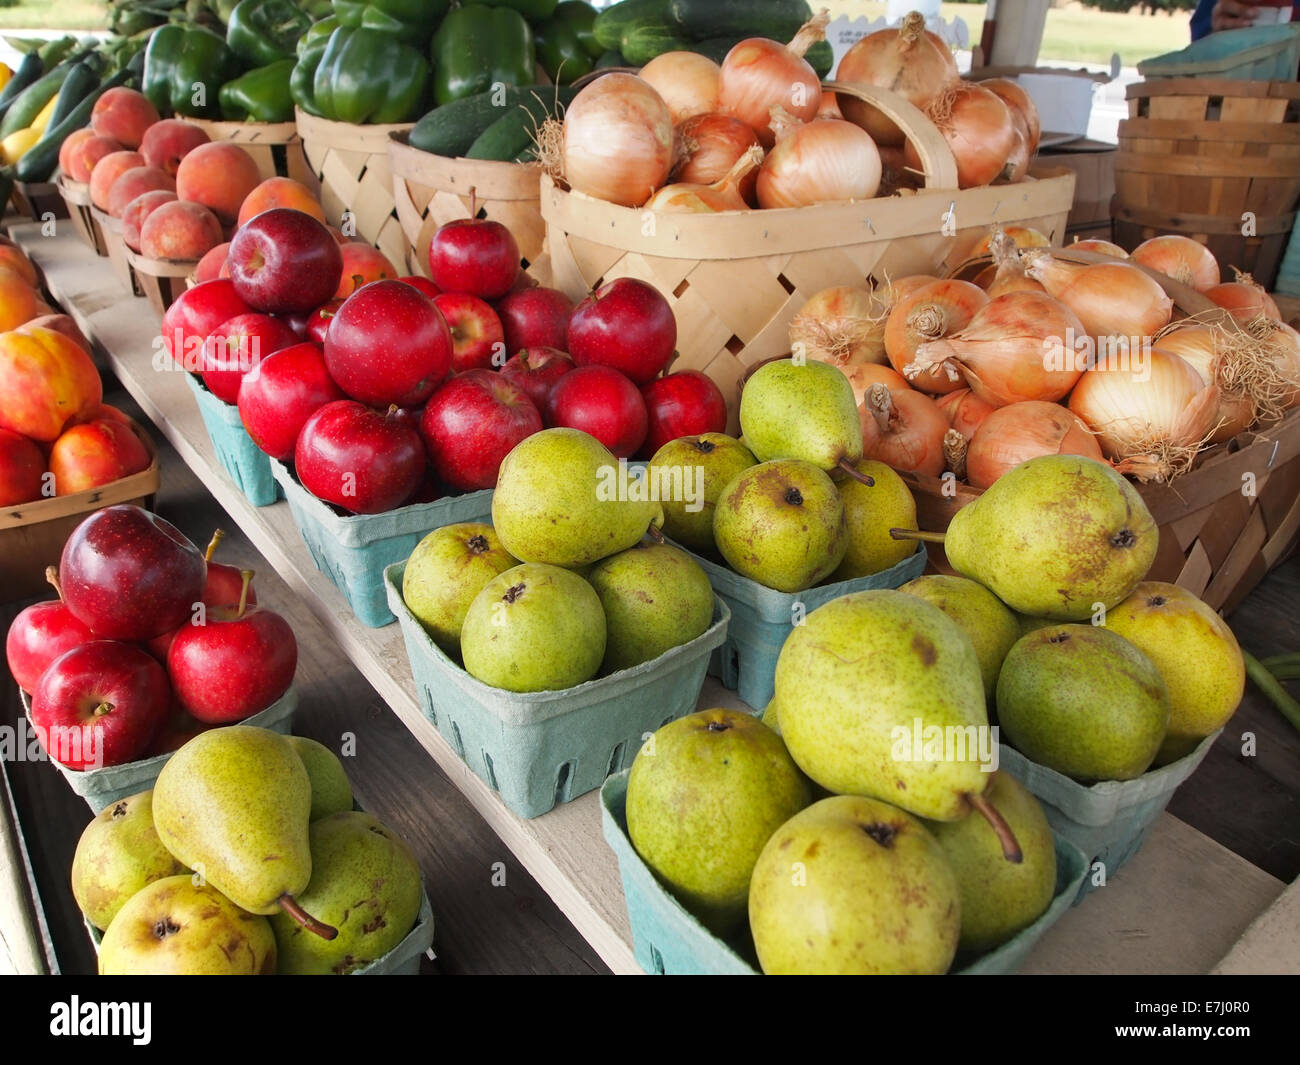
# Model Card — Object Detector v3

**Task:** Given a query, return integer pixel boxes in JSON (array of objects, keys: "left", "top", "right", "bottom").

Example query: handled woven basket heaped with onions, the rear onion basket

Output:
[{"left": 541, "top": 20, "right": 1074, "bottom": 421}]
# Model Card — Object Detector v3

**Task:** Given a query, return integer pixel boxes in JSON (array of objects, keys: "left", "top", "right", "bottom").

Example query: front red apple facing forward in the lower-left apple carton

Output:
[{"left": 31, "top": 640, "right": 172, "bottom": 770}]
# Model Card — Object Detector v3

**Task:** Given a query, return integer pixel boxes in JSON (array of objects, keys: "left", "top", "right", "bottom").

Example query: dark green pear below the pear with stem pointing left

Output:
[{"left": 997, "top": 624, "right": 1169, "bottom": 783}]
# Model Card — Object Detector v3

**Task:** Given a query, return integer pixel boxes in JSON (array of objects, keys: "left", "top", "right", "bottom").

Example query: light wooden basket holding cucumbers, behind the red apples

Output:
[{"left": 389, "top": 133, "right": 546, "bottom": 276}]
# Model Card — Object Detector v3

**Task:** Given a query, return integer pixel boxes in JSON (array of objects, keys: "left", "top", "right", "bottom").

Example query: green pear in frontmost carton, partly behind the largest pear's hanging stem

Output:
[{"left": 926, "top": 770, "right": 1056, "bottom": 954}]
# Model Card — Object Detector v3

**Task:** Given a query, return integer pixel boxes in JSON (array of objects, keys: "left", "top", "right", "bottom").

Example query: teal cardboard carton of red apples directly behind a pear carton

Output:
[{"left": 270, "top": 459, "right": 491, "bottom": 628}]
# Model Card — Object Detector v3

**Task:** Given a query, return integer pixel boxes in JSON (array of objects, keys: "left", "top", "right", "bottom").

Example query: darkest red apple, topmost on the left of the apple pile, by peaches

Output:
[{"left": 228, "top": 207, "right": 343, "bottom": 313}]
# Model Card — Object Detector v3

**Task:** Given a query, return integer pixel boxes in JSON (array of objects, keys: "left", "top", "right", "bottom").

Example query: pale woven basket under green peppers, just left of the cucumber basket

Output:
[{"left": 295, "top": 111, "right": 413, "bottom": 264}]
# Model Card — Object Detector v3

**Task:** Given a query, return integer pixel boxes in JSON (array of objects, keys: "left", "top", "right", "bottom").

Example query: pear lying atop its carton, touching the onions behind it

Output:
[{"left": 740, "top": 359, "right": 862, "bottom": 471}]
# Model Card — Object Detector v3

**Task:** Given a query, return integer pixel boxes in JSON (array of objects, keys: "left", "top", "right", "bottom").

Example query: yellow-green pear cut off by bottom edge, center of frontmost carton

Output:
[{"left": 749, "top": 796, "right": 962, "bottom": 975}]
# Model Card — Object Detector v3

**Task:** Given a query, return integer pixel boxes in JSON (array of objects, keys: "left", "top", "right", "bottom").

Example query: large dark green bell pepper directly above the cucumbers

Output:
[{"left": 433, "top": 4, "right": 537, "bottom": 105}]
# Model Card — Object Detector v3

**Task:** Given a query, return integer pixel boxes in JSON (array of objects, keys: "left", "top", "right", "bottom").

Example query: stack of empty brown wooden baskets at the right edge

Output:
[{"left": 1112, "top": 78, "right": 1300, "bottom": 287}]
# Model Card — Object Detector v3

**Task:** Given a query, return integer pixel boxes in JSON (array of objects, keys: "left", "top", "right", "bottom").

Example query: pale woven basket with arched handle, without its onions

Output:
[{"left": 541, "top": 82, "right": 1074, "bottom": 423}]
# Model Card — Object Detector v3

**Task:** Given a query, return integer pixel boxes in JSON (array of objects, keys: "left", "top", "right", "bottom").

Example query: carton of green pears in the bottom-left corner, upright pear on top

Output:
[{"left": 72, "top": 726, "right": 433, "bottom": 977}]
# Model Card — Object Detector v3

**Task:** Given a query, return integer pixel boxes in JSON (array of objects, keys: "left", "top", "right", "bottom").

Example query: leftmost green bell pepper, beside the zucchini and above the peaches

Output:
[{"left": 142, "top": 25, "right": 241, "bottom": 118}]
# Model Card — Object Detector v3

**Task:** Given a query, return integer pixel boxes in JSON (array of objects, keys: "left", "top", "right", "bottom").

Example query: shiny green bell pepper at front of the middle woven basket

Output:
[{"left": 309, "top": 26, "right": 429, "bottom": 125}]
